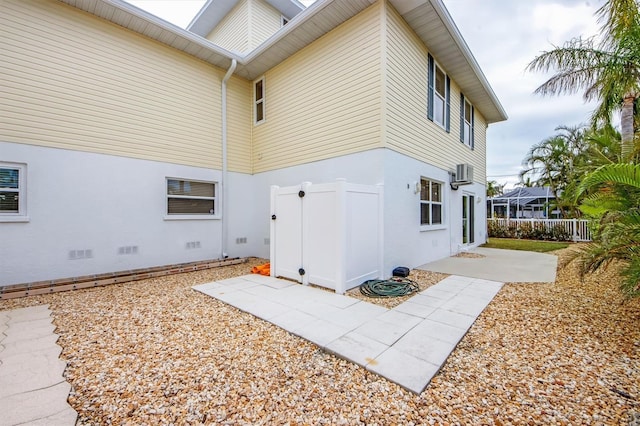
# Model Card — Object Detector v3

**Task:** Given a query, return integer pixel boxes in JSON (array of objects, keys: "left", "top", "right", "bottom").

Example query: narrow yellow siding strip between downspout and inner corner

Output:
[{"left": 227, "top": 77, "right": 252, "bottom": 173}]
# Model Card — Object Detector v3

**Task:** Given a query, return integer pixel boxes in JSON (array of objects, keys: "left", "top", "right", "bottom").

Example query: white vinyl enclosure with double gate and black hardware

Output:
[{"left": 271, "top": 179, "right": 384, "bottom": 294}]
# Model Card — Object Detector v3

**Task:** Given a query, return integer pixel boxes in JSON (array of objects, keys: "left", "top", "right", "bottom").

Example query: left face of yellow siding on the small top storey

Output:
[{"left": 206, "top": 0, "right": 251, "bottom": 53}]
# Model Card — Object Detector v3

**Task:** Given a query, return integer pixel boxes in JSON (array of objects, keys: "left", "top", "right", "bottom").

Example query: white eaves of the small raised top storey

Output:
[{"left": 187, "top": 0, "right": 305, "bottom": 37}]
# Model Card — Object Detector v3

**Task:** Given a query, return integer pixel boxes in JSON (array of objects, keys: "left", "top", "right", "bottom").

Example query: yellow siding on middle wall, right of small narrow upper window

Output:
[{"left": 253, "top": 3, "right": 382, "bottom": 172}]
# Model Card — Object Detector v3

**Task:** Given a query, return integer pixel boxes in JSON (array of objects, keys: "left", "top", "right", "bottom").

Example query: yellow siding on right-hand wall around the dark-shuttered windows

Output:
[{"left": 386, "top": 4, "right": 486, "bottom": 182}]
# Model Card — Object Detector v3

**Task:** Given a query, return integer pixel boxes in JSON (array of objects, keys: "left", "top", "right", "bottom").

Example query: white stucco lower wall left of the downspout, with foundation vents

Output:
[{"left": 0, "top": 142, "right": 242, "bottom": 285}]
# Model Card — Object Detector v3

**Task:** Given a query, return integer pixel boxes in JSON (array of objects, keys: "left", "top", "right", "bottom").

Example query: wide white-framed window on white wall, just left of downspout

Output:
[{"left": 167, "top": 178, "right": 216, "bottom": 216}]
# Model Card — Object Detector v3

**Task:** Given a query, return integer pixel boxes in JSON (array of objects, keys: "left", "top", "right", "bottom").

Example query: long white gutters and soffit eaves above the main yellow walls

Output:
[{"left": 59, "top": 0, "right": 507, "bottom": 123}]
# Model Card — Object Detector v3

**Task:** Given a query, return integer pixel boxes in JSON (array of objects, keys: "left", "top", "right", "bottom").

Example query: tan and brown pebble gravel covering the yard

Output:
[{"left": 0, "top": 249, "right": 640, "bottom": 425}]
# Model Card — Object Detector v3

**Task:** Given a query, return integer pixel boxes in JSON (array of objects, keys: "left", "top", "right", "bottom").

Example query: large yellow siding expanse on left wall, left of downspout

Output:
[{"left": 0, "top": 0, "right": 223, "bottom": 168}]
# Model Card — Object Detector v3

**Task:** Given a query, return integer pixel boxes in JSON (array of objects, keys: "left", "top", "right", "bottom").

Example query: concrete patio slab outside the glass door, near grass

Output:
[{"left": 416, "top": 247, "right": 558, "bottom": 283}]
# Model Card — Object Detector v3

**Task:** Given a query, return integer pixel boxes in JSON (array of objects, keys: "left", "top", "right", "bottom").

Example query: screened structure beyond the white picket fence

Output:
[{"left": 487, "top": 186, "right": 558, "bottom": 219}]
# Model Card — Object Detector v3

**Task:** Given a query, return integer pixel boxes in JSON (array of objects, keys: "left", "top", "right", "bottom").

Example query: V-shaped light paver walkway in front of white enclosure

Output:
[{"left": 193, "top": 275, "right": 502, "bottom": 393}]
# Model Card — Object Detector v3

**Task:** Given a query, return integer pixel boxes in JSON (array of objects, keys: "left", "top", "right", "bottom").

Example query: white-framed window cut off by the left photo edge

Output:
[{"left": 0, "top": 163, "right": 27, "bottom": 222}]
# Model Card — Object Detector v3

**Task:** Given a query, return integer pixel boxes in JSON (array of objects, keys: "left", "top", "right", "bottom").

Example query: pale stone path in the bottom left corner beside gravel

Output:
[{"left": 0, "top": 305, "right": 77, "bottom": 426}]
